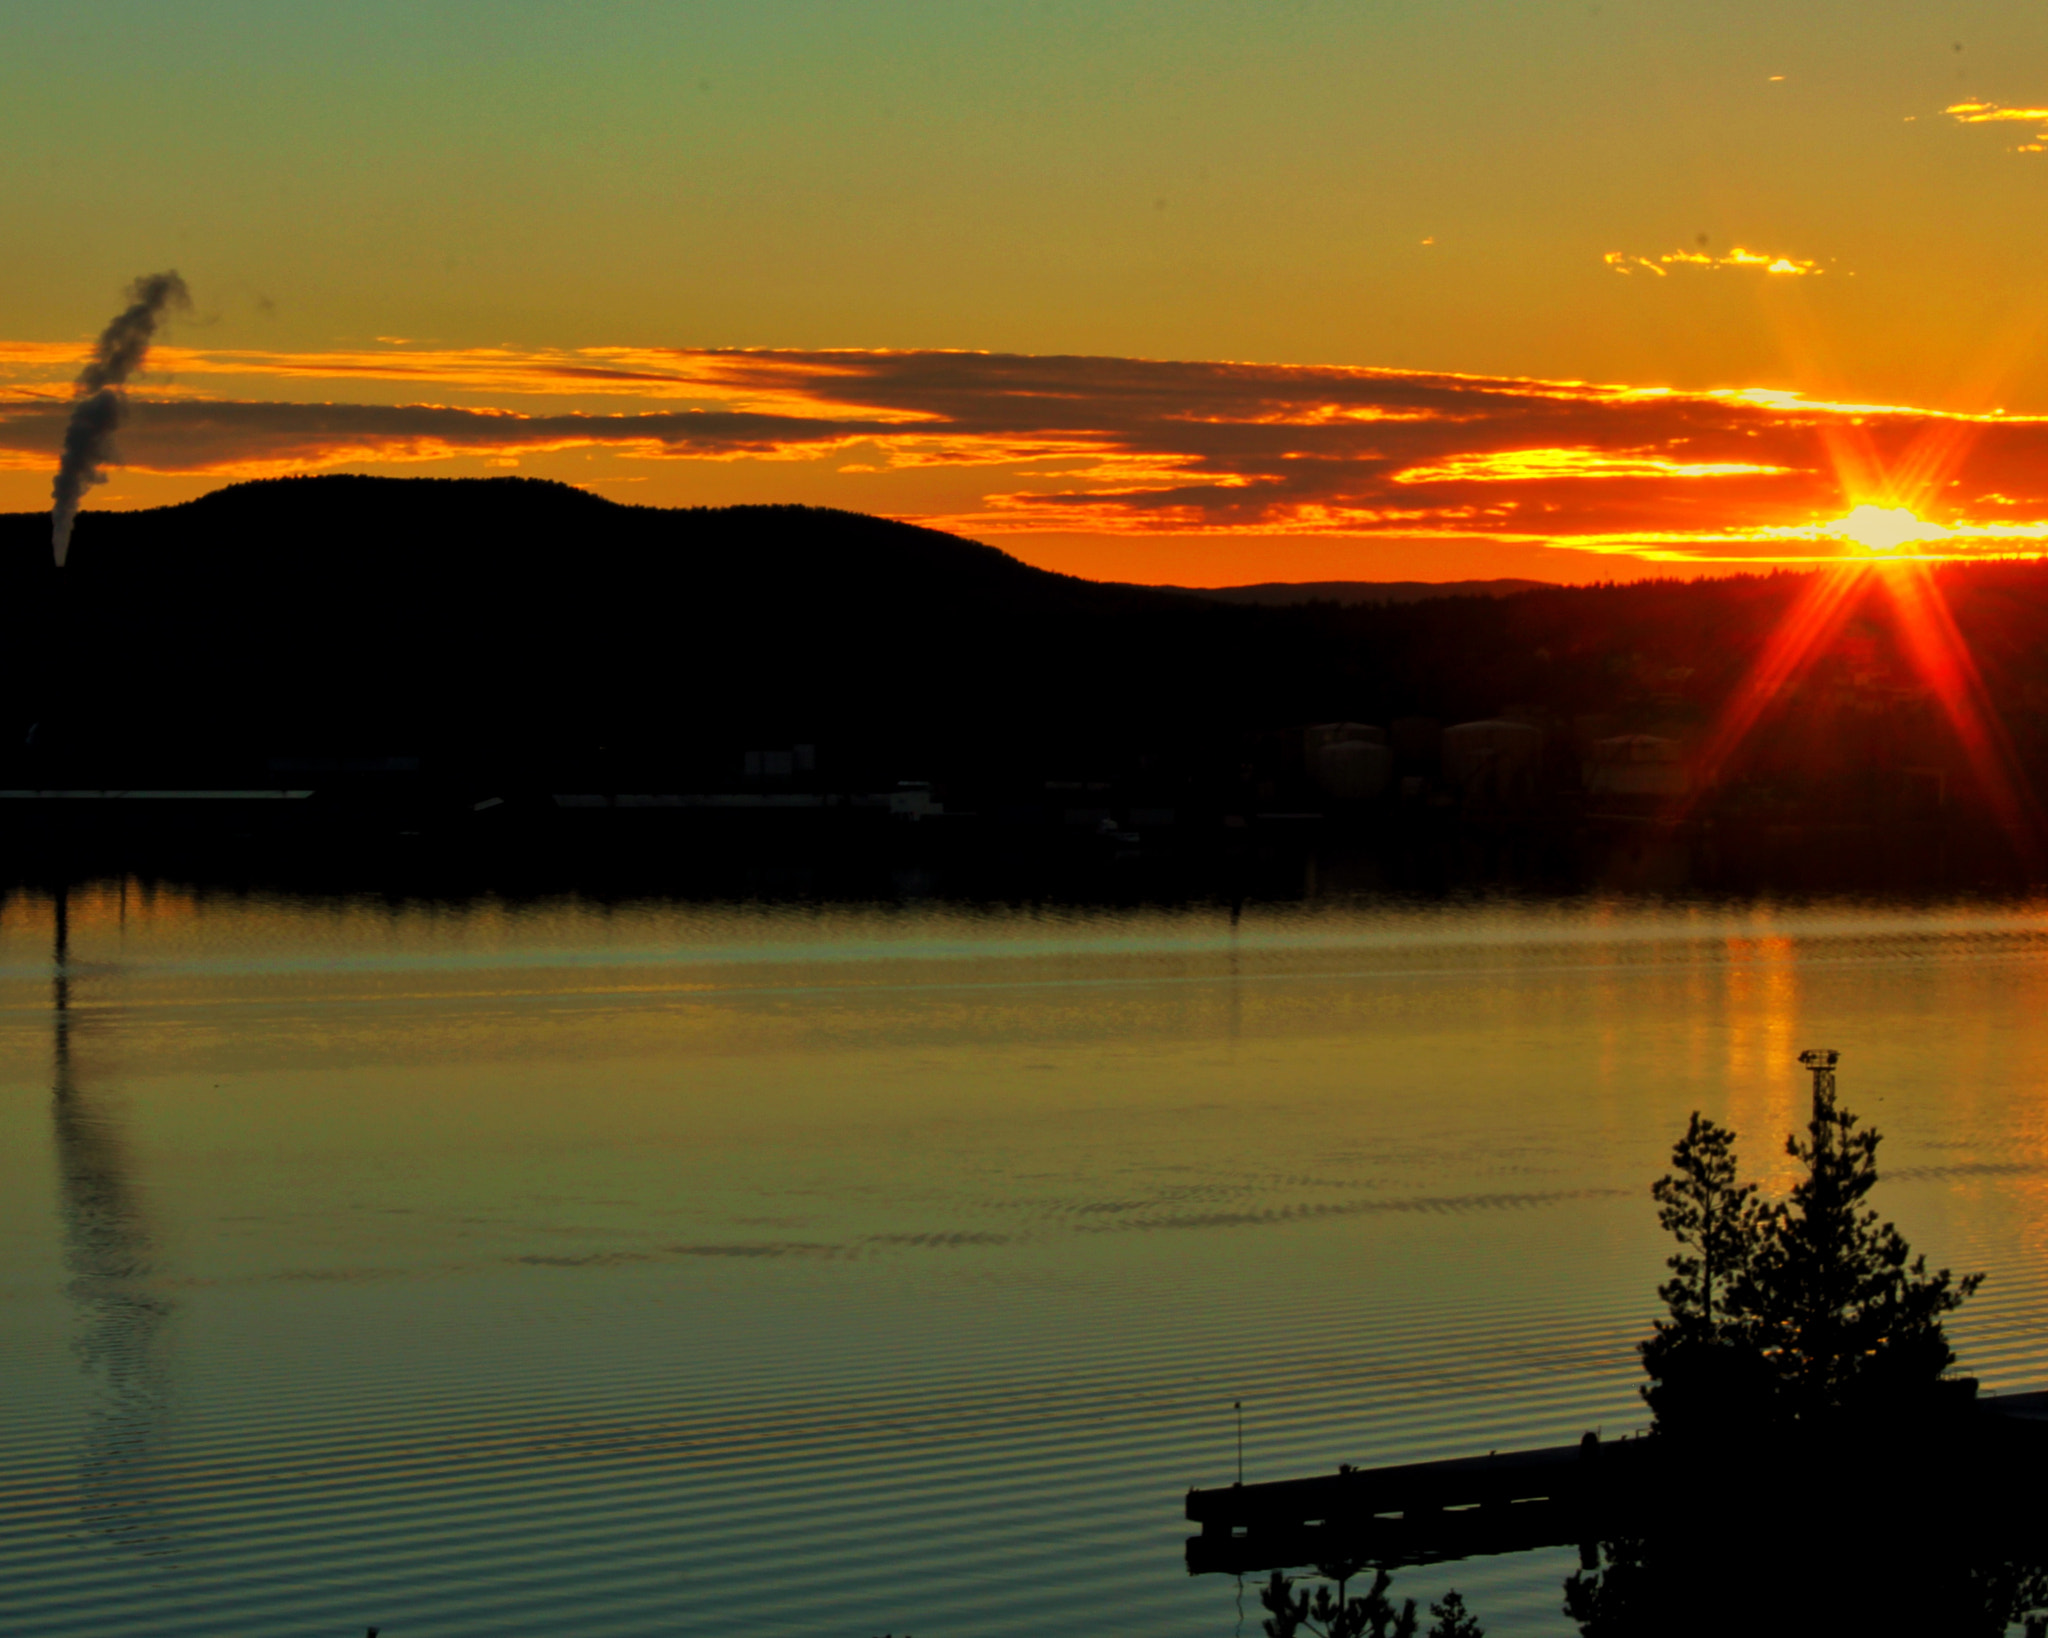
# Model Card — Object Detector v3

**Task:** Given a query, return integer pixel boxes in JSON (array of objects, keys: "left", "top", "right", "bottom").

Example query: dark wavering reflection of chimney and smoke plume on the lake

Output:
[{"left": 51, "top": 885, "right": 172, "bottom": 1552}]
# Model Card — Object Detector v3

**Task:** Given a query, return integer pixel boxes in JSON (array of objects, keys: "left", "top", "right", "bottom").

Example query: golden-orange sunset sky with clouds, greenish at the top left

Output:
[{"left": 0, "top": 0, "right": 2048, "bottom": 584}]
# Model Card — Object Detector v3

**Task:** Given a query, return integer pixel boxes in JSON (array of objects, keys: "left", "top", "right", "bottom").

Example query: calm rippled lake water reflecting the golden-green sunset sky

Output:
[{"left": 0, "top": 882, "right": 2048, "bottom": 1638}]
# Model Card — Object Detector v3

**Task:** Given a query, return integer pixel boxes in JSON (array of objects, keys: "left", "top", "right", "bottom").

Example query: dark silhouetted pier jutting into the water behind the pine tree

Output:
[{"left": 1188, "top": 1392, "right": 2048, "bottom": 1575}]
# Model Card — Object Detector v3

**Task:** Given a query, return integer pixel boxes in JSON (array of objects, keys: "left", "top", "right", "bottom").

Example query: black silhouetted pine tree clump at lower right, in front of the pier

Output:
[{"left": 1565, "top": 1052, "right": 2023, "bottom": 1638}]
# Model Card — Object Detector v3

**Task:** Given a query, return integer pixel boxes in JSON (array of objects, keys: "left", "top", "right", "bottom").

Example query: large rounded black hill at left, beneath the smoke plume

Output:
[{"left": 0, "top": 477, "right": 1310, "bottom": 774}]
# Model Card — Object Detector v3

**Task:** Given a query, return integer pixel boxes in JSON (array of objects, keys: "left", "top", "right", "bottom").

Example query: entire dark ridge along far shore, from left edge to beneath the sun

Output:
[{"left": 12, "top": 477, "right": 2048, "bottom": 805}]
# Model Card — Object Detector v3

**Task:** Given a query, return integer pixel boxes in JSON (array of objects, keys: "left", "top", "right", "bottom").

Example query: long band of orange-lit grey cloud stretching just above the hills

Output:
[{"left": 0, "top": 342, "right": 2048, "bottom": 563}]
